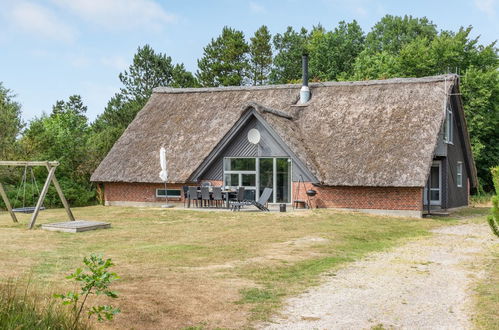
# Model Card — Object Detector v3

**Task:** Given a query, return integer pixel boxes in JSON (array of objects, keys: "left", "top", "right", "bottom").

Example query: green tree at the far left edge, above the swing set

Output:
[{"left": 0, "top": 82, "right": 24, "bottom": 159}]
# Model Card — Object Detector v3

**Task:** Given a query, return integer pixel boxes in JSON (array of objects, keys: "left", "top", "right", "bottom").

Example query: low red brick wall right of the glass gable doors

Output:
[{"left": 293, "top": 182, "right": 423, "bottom": 211}]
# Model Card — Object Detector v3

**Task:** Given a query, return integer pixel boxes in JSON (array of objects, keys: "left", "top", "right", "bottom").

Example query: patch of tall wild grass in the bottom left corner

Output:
[{"left": 0, "top": 280, "right": 89, "bottom": 330}]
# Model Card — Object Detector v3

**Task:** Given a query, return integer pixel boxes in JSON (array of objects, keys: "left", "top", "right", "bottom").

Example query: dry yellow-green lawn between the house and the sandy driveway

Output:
[{"left": 0, "top": 206, "right": 492, "bottom": 328}]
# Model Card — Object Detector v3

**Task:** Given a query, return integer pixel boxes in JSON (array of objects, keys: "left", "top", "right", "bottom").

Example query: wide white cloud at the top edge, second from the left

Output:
[{"left": 52, "top": 0, "right": 177, "bottom": 30}]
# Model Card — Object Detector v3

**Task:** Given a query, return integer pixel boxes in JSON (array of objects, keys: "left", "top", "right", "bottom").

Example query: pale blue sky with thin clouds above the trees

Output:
[{"left": 0, "top": 0, "right": 499, "bottom": 121}]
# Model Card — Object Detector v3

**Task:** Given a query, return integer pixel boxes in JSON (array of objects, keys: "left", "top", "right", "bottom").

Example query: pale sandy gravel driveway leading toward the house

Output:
[{"left": 259, "top": 224, "right": 497, "bottom": 329}]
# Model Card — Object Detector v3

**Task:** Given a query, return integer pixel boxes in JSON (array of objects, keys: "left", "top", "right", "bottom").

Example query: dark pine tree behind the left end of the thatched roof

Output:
[{"left": 119, "top": 45, "right": 196, "bottom": 104}]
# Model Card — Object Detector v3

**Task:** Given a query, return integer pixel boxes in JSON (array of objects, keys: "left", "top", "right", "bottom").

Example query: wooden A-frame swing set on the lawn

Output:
[{"left": 0, "top": 161, "right": 75, "bottom": 229}]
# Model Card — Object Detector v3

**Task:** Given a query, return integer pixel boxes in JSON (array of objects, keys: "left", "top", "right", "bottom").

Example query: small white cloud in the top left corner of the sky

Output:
[{"left": 8, "top": 1, "right": 74, "bottom": 42}]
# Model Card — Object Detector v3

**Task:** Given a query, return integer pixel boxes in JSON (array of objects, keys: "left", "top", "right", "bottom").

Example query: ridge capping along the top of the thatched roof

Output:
[{"left": 153, "top": 73, "right": 458, "bottom": 94}]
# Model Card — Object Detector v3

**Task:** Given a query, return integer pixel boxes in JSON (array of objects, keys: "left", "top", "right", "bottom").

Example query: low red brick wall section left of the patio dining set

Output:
[{"left": 104, "top": 182, "right": 187, "bottom": 203}]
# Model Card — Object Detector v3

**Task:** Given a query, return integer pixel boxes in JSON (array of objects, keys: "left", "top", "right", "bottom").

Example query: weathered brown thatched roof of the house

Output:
[{"left": 92, "top": 75, "right": 476, "bottom": 187}]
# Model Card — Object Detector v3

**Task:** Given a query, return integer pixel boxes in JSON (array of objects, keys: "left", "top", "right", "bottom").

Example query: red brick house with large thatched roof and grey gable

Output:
[{"left": 91, "top": 65, "right": 477, "bottom": 217}]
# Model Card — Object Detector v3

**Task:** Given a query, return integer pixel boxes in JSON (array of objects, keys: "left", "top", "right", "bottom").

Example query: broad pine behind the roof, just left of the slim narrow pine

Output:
[{"left": 196, "top": 26, "right": 250, "bottom": 87}]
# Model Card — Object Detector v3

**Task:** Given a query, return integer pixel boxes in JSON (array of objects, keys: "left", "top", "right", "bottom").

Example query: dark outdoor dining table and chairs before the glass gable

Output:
[{"left": 183, "top": 184, "right": 272, "bottom": 211}]
